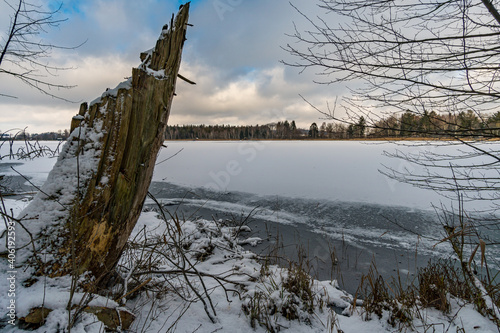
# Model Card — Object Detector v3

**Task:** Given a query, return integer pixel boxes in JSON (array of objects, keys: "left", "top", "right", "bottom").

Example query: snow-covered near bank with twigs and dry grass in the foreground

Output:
[{"left": 0, "top": 183, "right": 498, "bottom": 333}]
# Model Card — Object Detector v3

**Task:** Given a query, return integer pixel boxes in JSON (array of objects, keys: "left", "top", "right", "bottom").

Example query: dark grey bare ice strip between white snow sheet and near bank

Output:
[{"left": 150, "top": 182, "right": 458, "bottom": 293}]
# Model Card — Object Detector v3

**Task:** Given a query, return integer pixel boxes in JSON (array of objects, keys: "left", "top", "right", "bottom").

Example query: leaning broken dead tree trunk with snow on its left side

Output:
[{"left": 18, "top": 3, "right": 189, "bottom": 285}]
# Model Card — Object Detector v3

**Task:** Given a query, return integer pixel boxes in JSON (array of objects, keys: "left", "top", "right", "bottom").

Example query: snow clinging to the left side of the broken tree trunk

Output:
[{"left": 4, "top": 123, "right": 103, "bottom": 263}]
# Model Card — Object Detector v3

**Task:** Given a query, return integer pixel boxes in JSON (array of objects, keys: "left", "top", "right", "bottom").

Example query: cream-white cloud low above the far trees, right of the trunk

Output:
[{"left": 169, "top": 62, "right": 336, "bottom": 127}]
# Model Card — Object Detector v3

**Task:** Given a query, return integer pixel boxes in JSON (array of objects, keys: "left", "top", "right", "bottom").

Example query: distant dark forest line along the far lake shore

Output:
[{"left": 4, "top": 111, "right": 500, "bottom": 141}]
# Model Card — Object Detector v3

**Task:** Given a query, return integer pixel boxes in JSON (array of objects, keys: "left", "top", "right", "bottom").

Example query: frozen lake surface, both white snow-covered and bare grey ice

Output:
[{"left": 0, "top": 141, "right": 498, "bottom": 292}]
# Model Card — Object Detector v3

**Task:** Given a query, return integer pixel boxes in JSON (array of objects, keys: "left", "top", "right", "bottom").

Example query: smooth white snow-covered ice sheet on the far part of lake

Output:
[{"left": 154, "top": 141, "right": 456, "bottom": 209}]
